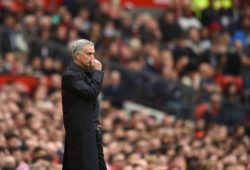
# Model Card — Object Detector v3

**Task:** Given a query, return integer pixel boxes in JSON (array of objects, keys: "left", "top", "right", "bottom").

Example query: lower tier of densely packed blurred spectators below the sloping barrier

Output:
[{"left": 0, "top": 80, "right": 250, "bottom": 170}]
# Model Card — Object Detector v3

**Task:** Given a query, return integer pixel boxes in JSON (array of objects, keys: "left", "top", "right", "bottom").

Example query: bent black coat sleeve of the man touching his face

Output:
[{"left": 63, "top": 70, "right": 103, "bottom": 99}]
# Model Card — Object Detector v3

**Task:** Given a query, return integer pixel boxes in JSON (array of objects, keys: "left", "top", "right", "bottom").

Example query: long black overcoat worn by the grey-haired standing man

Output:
[{"left": 62, "top": 61, "right": 103, "bottom": 170}]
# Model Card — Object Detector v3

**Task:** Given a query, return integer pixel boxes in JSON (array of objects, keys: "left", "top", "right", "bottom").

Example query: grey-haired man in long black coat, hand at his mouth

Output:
[{"left": 62, "top": 39, "right": 107, "bottom": 170}]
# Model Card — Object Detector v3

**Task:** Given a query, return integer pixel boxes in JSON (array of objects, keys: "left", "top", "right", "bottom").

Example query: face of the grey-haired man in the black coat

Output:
[{"left": 75, "top": 45, "right": 95, "bottom": 68}]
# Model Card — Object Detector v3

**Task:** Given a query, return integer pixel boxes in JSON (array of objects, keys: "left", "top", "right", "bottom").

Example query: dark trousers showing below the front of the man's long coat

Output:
[{"left": 95, "top": 126, "right": 107, "bottom": 170}]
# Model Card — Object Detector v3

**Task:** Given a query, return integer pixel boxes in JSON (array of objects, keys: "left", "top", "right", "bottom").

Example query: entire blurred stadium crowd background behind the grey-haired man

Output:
[{"left": 0, "top": 0, "right": 250, "bottom": 170}]
